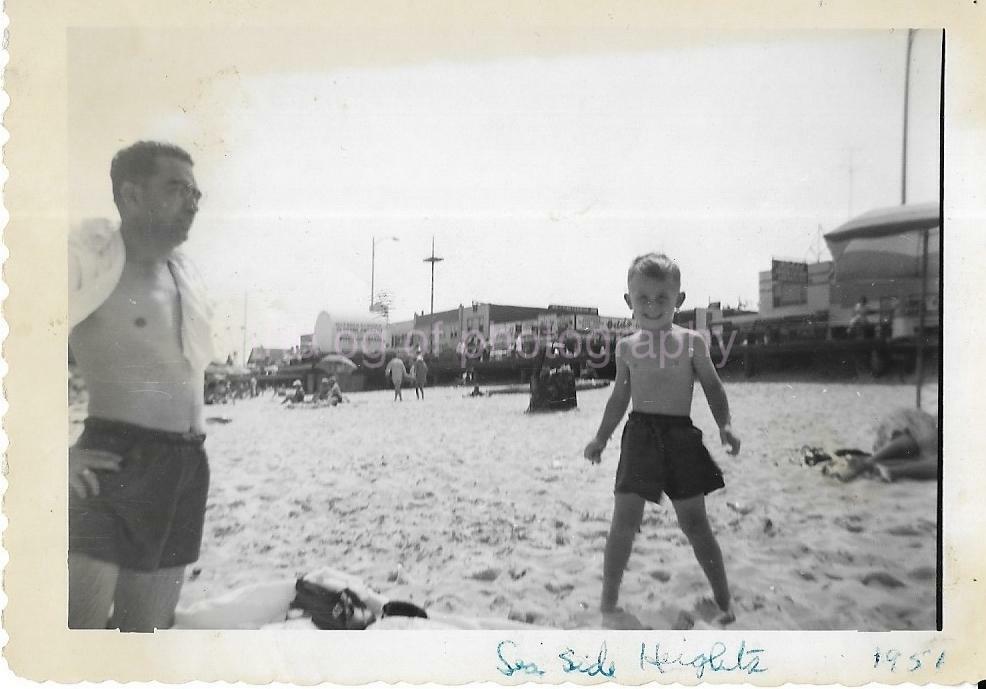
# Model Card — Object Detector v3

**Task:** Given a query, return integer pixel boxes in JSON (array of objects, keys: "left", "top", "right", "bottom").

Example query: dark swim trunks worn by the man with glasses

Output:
[{"left": 69, "top": 418, "right": 209, "bottom": 571}]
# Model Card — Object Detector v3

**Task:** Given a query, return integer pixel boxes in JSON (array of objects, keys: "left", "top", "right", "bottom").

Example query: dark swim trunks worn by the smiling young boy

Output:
[{"left": 615, "top": 412, "right": 725, "bottom": 502}]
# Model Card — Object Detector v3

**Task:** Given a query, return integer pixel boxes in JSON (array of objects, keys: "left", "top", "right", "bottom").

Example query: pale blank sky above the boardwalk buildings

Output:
[{"left": 69, "top": 30, "right": 941, "bottom": 351}]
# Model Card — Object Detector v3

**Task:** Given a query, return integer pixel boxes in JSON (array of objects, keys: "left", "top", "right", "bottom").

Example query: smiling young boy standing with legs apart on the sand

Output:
[{"left": 585, "top": 253, "right": 740, "bottom": 624}]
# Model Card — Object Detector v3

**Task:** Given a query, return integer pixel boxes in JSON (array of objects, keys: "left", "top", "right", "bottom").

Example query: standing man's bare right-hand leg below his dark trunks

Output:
[{"left": 111, "top": 567, "right": 185, "bottom": 632}]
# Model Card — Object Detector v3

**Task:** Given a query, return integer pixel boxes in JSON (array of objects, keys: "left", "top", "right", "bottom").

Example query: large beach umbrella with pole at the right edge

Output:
[{"left": 825, "top": 203, "right": 941, "bottom": 409}]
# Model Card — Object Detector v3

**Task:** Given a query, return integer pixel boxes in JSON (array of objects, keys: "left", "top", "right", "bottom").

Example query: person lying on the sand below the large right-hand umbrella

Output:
[{"left": 833, "top": 409, "right": 938, "bottom": 483}]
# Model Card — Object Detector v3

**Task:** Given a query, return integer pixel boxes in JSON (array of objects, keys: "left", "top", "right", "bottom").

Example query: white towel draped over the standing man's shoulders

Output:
[{"left": 68, "top": 218, "right": 213, "bottom": 370}]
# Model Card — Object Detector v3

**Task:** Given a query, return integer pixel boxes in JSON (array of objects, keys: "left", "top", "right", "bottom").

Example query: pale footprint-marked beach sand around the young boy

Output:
[{"left": 70, "top": 382, "right": 937, "bottom": 630}]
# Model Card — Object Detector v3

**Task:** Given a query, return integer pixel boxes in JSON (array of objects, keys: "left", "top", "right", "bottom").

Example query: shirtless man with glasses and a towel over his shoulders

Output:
[{"left": 68, "top": 142, "right": 212, "bottom": 631}]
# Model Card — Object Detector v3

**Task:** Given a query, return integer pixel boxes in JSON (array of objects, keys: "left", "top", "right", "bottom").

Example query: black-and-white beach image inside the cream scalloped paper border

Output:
[{"left": 61, "top": 24, "right": 943, "bottom": 631}]
